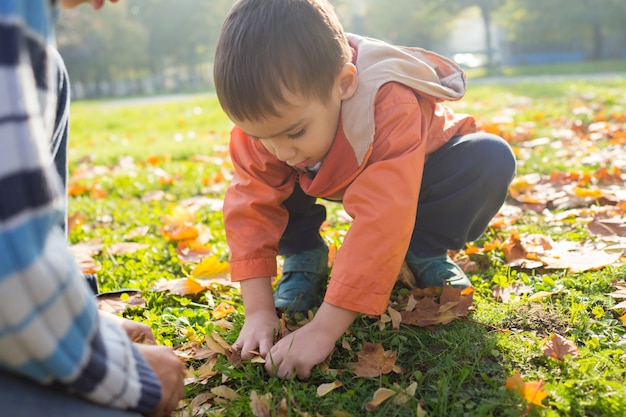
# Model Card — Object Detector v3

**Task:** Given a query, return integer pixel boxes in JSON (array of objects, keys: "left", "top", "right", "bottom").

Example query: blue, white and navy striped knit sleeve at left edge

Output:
[{"left": 0, "top": 0, "right": 161, "bottom": 413}]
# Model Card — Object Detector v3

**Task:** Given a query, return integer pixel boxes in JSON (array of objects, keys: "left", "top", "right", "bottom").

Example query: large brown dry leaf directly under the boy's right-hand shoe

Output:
[{"left": 400, "top": 285, "right": 474, "bottom": 327}]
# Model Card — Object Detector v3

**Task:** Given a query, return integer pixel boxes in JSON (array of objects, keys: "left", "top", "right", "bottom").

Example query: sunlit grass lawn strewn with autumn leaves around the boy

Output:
[{"left": 69, "top": 78, "right": 626, "bottom": 417}]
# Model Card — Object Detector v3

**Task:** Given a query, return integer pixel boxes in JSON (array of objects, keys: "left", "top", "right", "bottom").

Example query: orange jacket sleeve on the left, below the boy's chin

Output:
[{"left": 224, "top": 127, "right": 296, "bottom": 281}]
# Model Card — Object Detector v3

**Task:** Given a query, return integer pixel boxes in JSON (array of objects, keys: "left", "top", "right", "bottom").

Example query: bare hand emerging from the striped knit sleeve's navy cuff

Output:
[{"left": 135, "top": 344, "right": 185, "bottom": 417}]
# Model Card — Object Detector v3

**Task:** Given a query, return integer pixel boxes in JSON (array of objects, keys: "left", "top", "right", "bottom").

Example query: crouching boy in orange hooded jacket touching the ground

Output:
[{"left": 214, "top": 0, "right": 515, "bottom": 378}]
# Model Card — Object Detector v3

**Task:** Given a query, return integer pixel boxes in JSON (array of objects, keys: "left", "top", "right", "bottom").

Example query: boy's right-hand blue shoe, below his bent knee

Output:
[{"left": 406, "top": 252, "right": 472, "bottom": 288}]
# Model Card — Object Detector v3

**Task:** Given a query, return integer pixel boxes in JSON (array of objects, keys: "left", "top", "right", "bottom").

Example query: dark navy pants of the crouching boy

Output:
[{"left": 279, "top": 132, "right": 516, "bottom": 258}]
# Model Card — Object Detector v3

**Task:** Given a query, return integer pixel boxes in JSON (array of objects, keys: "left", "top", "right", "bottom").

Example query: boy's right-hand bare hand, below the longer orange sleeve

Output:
[{"left": 265, "top": 303, "right": 358, "bottom": 379}]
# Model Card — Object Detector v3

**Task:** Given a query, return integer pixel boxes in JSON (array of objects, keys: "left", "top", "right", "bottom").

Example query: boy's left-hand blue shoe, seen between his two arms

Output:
[{"left": 274, "top": 246, "right": 328, "bottom": 313}]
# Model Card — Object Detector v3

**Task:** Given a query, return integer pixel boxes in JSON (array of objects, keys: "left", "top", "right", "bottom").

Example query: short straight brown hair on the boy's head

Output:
[{"left": 213, "top": 0, "right": 352, "bottom": 121}]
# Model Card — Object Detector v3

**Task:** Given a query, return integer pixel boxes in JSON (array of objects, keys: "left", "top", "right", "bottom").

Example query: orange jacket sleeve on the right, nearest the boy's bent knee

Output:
[{"left": 325, "top": 83, "right": 432, "bottom": 314}]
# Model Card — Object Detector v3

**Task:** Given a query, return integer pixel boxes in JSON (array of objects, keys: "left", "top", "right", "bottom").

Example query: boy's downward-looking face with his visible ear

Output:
[{"left": 233, "top": 64, "right": 357, "bottom": 170}]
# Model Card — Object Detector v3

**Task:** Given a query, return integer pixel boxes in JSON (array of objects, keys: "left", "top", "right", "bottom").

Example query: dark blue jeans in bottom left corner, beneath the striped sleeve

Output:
[{"left": 0, "top": 370, "right": 141, "bottom": 417}]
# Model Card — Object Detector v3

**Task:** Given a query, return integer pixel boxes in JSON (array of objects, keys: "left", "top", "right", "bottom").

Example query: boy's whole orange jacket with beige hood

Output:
[{"left": 224, "top": 35, "right": 475, "bottom": 314}]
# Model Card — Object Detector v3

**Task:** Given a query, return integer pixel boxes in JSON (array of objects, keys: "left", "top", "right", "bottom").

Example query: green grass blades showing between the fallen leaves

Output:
[{"left": 70, "top": 79, "right": 626, "bottom": 417}]
